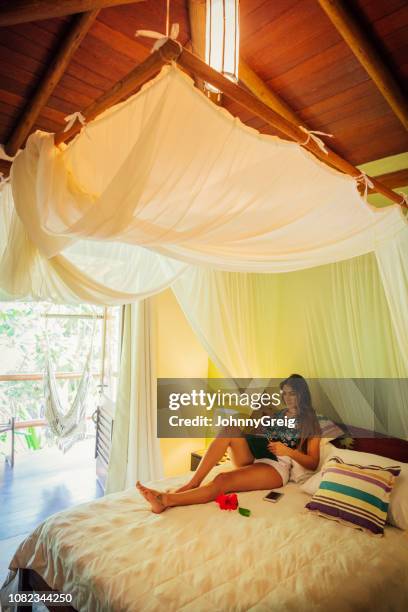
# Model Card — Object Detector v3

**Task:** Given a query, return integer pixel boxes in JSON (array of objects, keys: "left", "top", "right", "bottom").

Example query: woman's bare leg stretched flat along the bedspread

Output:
[{"left": 136, "top": 463, "right": 283, "bottom": 514}]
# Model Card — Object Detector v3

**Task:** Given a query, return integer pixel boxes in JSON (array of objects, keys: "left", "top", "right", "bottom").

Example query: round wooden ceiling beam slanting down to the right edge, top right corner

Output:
[{"left": 318, "top": 0, "right": 408, "bottom": 129}]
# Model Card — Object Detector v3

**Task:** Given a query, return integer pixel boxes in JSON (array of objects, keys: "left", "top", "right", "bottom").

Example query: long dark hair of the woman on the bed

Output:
[{"left": 279, "top": 374, "right": 321, "bottom": 450}]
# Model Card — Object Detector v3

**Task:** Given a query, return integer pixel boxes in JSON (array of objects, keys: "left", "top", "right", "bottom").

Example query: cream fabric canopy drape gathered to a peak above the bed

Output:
[{"left": 0, "top": 66, "right": 404, "bottom": 303}]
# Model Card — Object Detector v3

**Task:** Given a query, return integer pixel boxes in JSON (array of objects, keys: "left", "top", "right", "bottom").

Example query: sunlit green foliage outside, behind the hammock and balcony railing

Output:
[{"left": 0, "top": 302, "right": 105, "bottom": 451}]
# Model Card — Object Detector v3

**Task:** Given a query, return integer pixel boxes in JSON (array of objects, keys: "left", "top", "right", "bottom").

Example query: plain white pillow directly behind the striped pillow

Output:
[{"left": 300, "top": 444, "right": 408, "bottom": 529}]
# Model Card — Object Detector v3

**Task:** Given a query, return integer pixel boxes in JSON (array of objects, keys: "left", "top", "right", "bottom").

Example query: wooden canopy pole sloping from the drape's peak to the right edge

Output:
[{"left": 176, "top": 43, "right": 406, "bottom": 207}]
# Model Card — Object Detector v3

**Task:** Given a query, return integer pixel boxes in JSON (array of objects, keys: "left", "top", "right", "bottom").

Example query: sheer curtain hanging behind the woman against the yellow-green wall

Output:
[{"left": 173, "top": 254, "right": 408, "bottom": 437}]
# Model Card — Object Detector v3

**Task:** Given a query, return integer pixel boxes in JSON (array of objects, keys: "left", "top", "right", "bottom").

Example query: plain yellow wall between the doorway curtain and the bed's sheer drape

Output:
[{"left": 154, "top": 289, "right": 208, "bottom": 476}]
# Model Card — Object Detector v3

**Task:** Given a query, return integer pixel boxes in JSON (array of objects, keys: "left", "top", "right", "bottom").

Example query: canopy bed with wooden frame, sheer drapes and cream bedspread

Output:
[{"left": 0, "top": 14, "right": 408, "bottom": 612}]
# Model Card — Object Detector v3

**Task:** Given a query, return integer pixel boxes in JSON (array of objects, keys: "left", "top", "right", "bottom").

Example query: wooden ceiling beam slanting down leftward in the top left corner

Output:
[{"left": 4, "top": 9, "right": 99, "bottom": 157}]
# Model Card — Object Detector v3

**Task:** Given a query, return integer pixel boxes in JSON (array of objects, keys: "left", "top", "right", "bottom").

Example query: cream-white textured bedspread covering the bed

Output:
[{"left": 0, "top": 466, "right": 408, "bottom": 612}]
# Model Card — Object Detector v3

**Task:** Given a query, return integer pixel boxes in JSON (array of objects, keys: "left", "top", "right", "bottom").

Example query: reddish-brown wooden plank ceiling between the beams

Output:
[{"left": 0, "top": 0, "right": 408, "bottom": 180}]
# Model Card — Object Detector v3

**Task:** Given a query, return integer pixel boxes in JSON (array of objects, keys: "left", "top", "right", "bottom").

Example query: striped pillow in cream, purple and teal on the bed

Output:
[{"left": 306, "top": 457, "right": 401, "bottom": 536}]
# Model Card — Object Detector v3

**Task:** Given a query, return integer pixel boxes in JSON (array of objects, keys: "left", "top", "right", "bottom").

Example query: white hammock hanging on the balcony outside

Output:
[{"left": 44, "top": 317, "right": 96, "bottom": 452}]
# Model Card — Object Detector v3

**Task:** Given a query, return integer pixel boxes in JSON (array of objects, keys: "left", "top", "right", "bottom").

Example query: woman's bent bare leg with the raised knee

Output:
[{"left": 175, "top": 431, "right": 254, "bottom": 493}]
